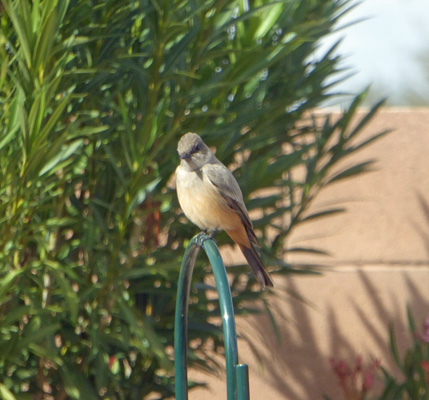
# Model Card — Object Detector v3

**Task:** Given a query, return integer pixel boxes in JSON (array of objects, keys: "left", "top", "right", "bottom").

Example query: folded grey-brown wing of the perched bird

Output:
[{"left": 201, "top": 162, "right": 259, "bottom": 246}]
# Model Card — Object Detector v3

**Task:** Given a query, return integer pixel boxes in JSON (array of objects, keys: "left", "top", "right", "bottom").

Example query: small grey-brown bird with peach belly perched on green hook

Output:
[{"left": 176, "top": 132, "right": 274, "bottom": 290}]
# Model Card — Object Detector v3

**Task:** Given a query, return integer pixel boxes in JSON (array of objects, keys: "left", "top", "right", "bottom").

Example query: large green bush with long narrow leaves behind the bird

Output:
[{"left": 0, "top": 0, "right": 382, "bottom": 400}]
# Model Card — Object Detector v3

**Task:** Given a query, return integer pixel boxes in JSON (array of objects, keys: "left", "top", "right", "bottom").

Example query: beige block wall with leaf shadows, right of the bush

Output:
[{"left": 190, "top": 108, "right": 429, "bottom": 400}]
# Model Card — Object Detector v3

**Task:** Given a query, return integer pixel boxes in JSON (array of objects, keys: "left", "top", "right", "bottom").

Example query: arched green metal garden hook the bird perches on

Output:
[{"left": 174, "top": 233, "right": 249, "bottom": 400}]
